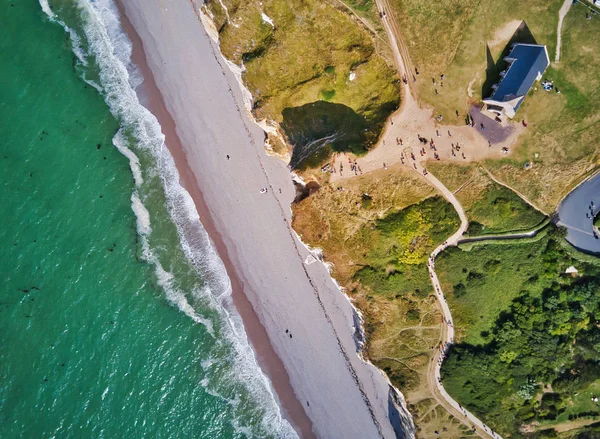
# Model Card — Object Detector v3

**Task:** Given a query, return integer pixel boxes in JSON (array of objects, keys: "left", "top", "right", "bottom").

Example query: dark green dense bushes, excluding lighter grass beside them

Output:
[{"left": 442, "top": 241, "right": 600, "bottom": 435}]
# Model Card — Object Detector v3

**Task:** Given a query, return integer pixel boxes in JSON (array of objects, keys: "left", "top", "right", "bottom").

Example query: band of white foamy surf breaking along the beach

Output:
[{"left": 40, "top": 0, "right": 297, "bottom": 438}]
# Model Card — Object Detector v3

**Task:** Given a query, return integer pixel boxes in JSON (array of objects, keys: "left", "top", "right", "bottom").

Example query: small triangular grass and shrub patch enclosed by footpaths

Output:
[{"left": 428, "top": 162, "right": 545, "bottom": 235}]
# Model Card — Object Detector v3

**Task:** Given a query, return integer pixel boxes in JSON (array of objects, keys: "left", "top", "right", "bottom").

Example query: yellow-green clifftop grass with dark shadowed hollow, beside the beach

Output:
[{"left": 208, "top": 0, "right": 400, "bottom": 166}]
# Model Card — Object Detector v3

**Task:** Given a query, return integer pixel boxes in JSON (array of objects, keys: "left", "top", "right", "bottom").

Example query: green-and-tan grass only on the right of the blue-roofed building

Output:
[{"left": 488, "top": 4, "right": 600, "bottom": 210}]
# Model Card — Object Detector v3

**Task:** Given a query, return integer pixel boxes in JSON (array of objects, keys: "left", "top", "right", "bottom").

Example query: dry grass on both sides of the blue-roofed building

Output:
[{"left": 393, "top": 0, "right": 600, "bottom": 211}]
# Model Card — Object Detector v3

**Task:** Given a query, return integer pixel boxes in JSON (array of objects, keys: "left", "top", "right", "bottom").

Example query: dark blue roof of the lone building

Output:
[{"left": 488, "top": 44, "right": 550, "bottom": 106}]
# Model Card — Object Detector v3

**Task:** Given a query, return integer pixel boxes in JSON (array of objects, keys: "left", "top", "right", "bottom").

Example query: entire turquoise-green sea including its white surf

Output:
[{"left": 0, "top": 0, "right": 295, "bottom": 439}]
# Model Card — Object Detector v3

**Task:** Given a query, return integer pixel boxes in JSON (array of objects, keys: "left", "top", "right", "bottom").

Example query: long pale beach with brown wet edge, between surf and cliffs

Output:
[{"left": 122, "top": 0, "right": 412, "bottom": 438}]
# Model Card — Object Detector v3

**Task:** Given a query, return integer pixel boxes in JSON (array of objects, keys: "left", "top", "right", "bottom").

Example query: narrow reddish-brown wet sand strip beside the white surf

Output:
[{"left": 116, "top": 0, "right": 315, "bottom": 438}]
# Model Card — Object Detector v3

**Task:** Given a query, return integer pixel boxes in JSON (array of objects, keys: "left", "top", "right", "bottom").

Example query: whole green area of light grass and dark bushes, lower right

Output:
[{"left": 436, "top": 226, "right": 600, "bottom": 437}]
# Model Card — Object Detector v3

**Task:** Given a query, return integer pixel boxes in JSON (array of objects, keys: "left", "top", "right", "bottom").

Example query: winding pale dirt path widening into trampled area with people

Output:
[{"left": 332, "top": 0, "right": 520, "bottom": 439}]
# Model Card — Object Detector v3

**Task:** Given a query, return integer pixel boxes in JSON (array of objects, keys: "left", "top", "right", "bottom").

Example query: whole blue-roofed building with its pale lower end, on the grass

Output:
[{"left": 483, "top": 43, "right": 550, "bottom": 119}]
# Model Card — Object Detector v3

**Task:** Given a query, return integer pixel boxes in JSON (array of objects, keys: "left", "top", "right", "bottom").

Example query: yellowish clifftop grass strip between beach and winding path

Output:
[{"left": 293, "top": 166, "right": 470, "bottom": 438}]
